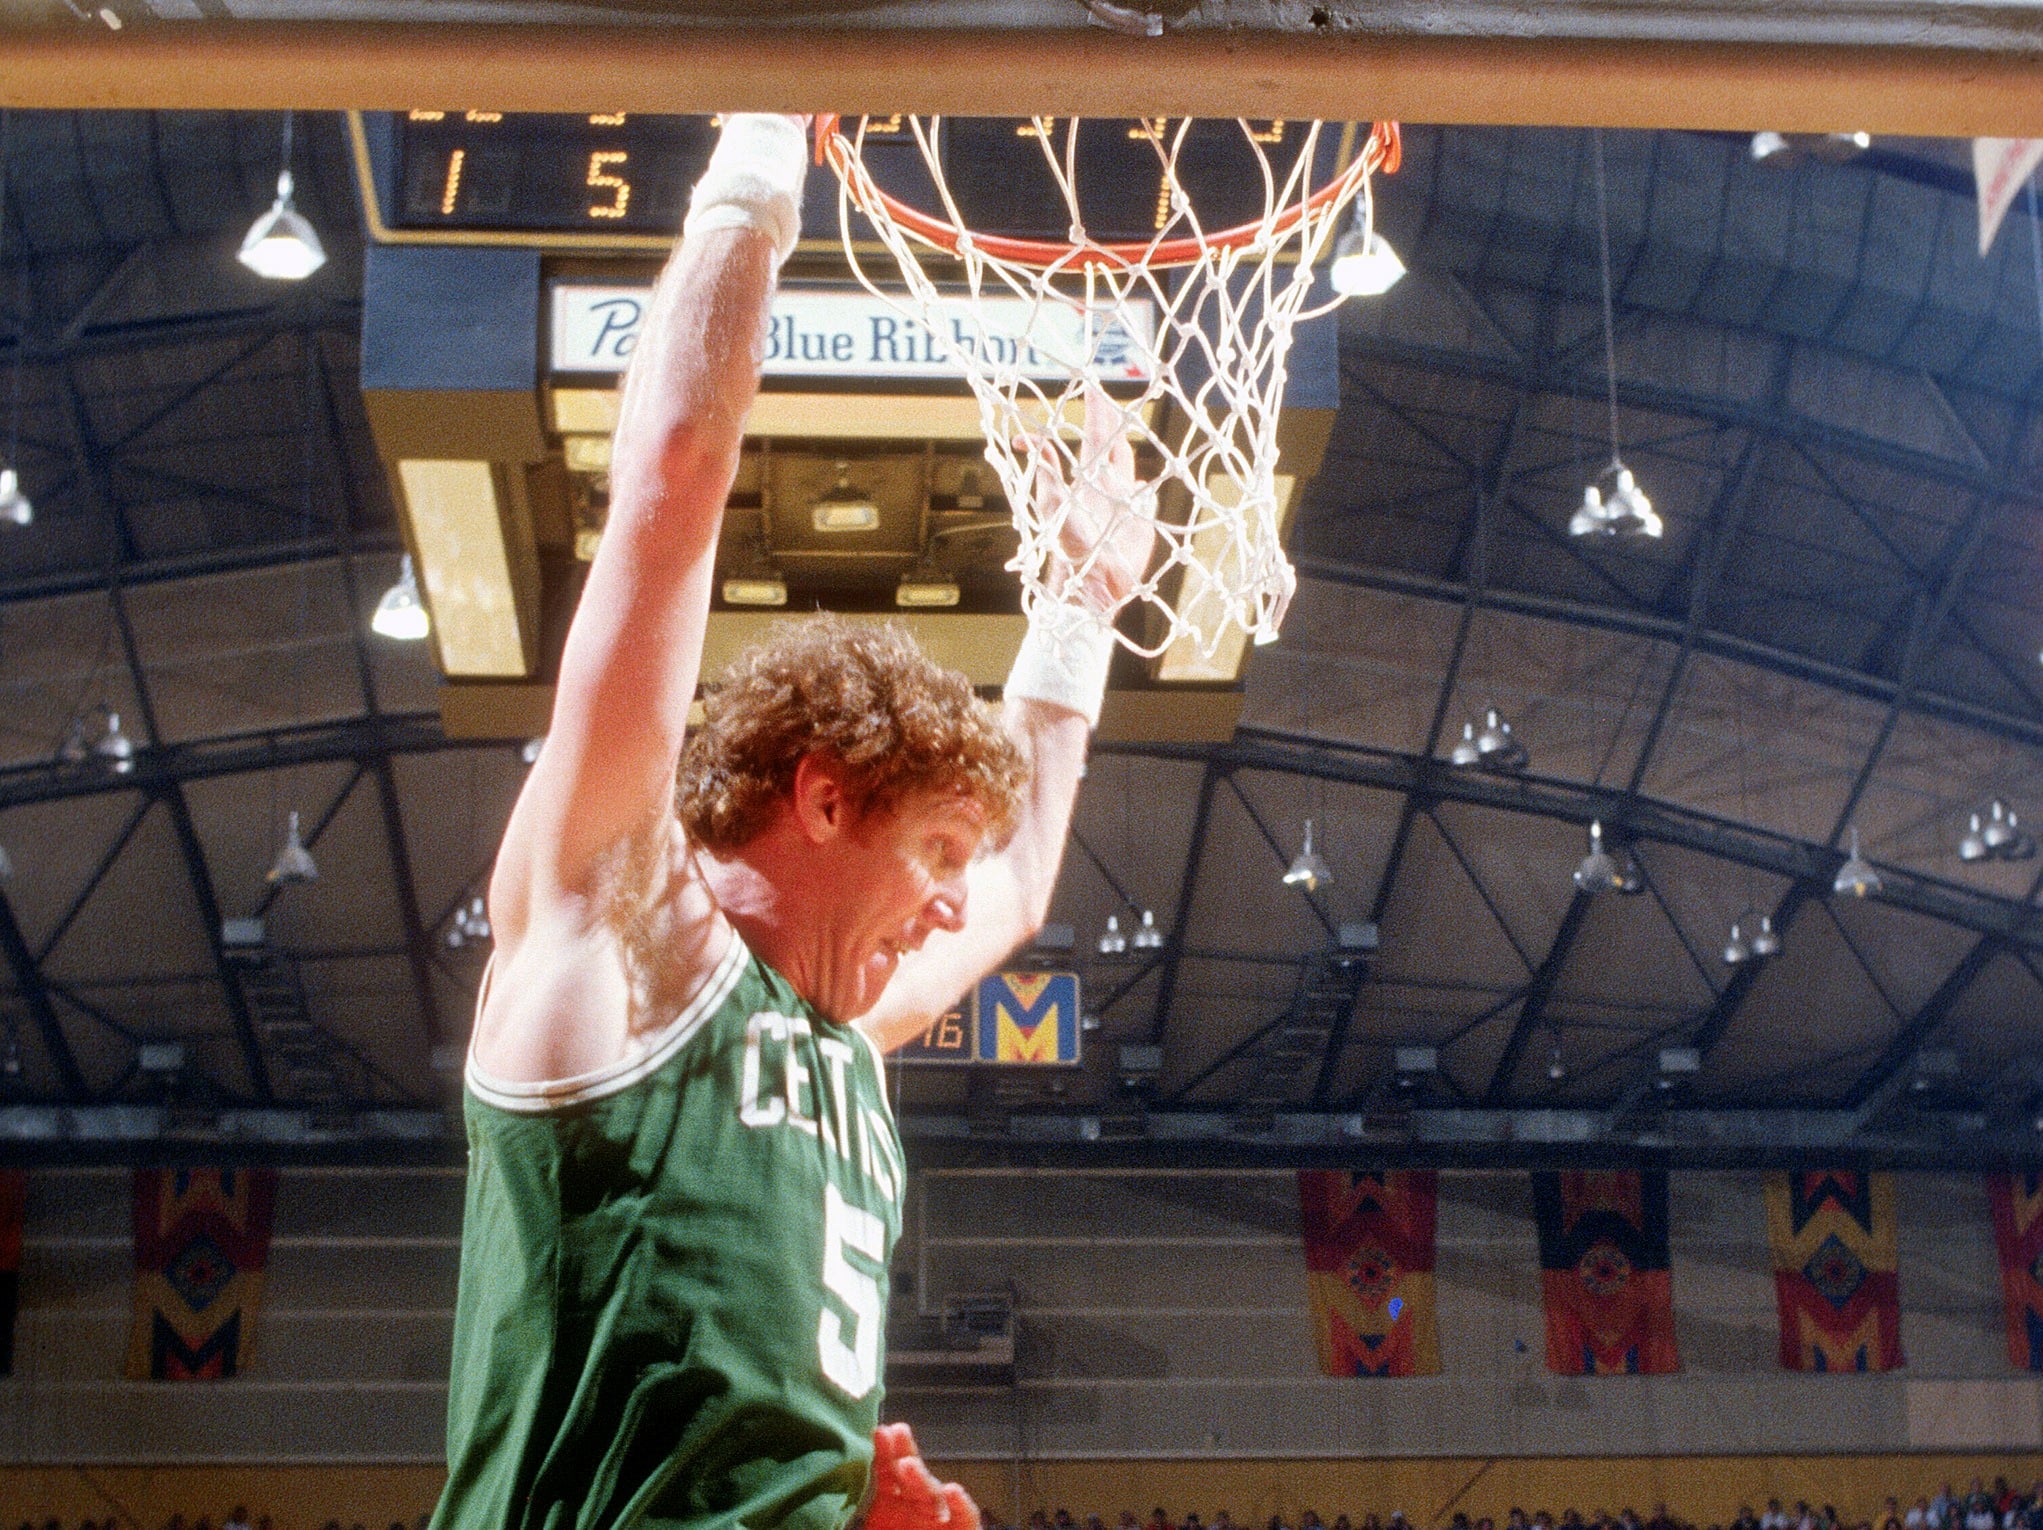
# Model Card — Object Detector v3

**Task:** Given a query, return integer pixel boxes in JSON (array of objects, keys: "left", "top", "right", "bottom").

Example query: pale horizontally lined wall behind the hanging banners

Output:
[{"left": 0, "top": 1170, "right": 2043, "bottom": 1463}]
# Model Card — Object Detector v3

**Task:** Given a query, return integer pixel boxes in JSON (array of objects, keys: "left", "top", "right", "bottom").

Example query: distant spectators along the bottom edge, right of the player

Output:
[{"left": 987, "top": 1477, "right": 2043, "bottom": 1530}]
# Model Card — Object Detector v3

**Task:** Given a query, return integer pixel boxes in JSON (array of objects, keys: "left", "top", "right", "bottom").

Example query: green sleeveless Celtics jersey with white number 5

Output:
[{"left": 433, "top": 936, "right": 903, "bottom": 1530}]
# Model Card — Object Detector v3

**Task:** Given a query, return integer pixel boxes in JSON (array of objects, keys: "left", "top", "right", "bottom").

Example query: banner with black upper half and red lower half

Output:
[{"left": 1532, "top": 1170, "right": 1681, "bottom": 1377}]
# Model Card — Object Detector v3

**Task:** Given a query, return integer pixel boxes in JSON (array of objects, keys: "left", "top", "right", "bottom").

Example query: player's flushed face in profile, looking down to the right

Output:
[{"left": 832, "top": 793, "right": 987, "bottom": 1019}]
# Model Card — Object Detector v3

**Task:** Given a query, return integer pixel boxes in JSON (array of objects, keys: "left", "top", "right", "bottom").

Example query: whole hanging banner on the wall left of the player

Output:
[{"left": 129, "top": 1168, "right": 276, "bottom": 1381}]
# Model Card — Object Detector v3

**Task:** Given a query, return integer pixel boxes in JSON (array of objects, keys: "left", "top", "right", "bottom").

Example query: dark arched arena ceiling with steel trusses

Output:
[{"left": 0, "top": 112, "right": 2043, "bottom": 1162}]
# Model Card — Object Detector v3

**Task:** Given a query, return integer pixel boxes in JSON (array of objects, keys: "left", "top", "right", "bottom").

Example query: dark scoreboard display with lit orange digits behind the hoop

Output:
[{"left": 364, "top": 110, "right": 1340, "bottom": 243}]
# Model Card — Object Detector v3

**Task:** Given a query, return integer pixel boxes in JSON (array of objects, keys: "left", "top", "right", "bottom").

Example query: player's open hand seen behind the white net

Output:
[{"left": 1028, "top": 384, "right": 1156, "bottom": 617}]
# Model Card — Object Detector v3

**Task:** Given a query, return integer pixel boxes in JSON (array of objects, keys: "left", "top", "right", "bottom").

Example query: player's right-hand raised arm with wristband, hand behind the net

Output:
[{"left": 860, "top": 390, "right": 1156, "bottom": 1050}]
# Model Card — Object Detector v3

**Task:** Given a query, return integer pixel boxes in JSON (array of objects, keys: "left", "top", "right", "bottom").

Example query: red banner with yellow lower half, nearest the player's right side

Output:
[{"left": 1297, "top": 1168, "right": 1440, "bottom": 1377}]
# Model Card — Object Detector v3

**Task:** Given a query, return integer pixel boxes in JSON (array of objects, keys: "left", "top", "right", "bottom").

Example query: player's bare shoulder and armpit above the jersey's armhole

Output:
[{"left": 470, "top": 825, "right": 746, "bottom": 1101}]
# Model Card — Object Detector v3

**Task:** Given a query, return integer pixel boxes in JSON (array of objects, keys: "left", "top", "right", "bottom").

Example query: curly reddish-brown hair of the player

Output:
[{"left": 674, "top": 615, "right": 1028, "bottom": 854}]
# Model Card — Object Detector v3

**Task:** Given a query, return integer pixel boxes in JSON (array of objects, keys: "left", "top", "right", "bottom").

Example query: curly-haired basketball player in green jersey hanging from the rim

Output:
[{"left": 433, "top": 116, "right": 1152, "bottom": 1530}]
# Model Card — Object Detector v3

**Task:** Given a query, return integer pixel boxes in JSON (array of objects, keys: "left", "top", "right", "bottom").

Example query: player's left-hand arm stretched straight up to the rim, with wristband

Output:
[{"left": 490, "top": 116, "right": 807, "bottom": 984}]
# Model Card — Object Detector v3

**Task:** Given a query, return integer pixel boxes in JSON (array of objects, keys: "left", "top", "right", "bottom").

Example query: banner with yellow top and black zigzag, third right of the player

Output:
[{"left": 1767, "top": 1168, "right": 1902, "bottom": 1371}]
